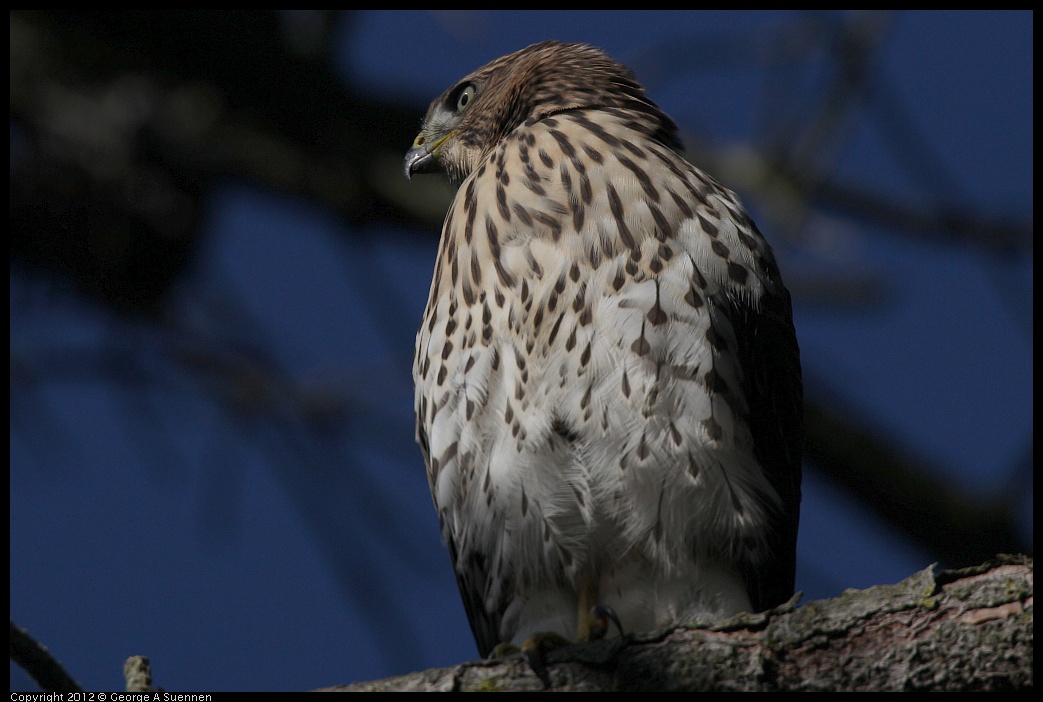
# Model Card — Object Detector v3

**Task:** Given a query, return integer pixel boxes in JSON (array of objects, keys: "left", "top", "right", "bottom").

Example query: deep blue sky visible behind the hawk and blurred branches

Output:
[{"left": 10, "top": 11, "right": 1033, "bottom": 691}]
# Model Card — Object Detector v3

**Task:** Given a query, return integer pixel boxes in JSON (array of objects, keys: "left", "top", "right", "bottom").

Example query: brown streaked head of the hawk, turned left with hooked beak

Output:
[{"left": 406, "top": 42, "right": 680, "bottom": 185}]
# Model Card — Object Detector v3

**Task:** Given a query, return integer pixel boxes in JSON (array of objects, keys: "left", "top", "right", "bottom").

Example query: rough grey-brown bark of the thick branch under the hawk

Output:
[{"left": 320, "top": 556, "right": 1033, "bottom": 692}]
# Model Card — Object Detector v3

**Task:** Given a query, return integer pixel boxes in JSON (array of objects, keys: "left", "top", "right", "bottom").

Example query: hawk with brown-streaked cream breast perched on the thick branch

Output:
[{"left": 405, "top": 42, "right": 803, "bottom": 656}]
